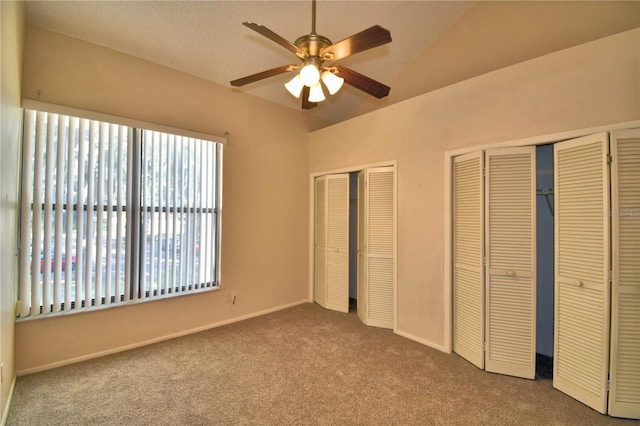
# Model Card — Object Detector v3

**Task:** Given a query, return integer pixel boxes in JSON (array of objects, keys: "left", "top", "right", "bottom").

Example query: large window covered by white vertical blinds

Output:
[{"left": 19, "top": 110, "right": 222, "bottom": 317}]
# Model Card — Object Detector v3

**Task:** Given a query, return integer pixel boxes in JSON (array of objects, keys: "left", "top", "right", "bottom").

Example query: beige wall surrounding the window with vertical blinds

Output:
[{"left": 16, "top": 27, "right": 326, "bottom": 373}]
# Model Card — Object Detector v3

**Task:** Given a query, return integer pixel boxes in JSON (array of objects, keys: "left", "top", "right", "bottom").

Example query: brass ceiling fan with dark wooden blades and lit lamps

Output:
[{"left": 231, "top": 0, "right": 391, "bottom": 109}]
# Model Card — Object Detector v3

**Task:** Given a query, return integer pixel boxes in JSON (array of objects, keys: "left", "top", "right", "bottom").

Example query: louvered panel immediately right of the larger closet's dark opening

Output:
[{"left": 553, "top": 133, "right": 610, "bottom": 413}]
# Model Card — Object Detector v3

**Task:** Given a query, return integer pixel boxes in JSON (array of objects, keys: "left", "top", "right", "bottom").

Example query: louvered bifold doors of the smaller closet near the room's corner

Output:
[{"left": 313, "top": 166, "right": 396, "bottom": 328}]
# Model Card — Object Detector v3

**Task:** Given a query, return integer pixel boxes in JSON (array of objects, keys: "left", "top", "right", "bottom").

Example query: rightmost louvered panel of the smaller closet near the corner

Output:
[{"left": 365, "top": 167, "right": 396, "bottom": 328}]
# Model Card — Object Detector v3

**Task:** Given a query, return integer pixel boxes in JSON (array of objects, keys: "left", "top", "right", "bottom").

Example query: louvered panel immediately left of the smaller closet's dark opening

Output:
[{"left": 326, "top": 173, "right": 349, "bottom": 312}]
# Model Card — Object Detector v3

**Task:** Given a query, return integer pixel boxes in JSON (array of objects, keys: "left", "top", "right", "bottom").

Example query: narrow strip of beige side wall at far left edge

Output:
[{"left": 0, "top": 1, "right": 26, "bottom": 424}]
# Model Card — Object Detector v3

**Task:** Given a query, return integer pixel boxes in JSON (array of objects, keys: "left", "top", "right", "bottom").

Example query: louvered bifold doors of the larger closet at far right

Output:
[{"left": 452, "top": 129, "right": 640, "bottom": 418}]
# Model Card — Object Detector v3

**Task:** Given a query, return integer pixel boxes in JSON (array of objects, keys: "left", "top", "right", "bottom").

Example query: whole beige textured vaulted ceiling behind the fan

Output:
[{"left": 27, "top": 0, "right": 640, "bottom": 122}]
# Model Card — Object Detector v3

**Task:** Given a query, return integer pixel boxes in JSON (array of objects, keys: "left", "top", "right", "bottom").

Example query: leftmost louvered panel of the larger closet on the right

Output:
[{"left": 453, "top": 151, "right": 484, "bottom": 368}]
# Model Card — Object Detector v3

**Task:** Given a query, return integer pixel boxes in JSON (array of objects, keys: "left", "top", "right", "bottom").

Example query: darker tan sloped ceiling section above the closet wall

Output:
[{"left": 353, "top": 0, "right": 640, "bottom": 117}]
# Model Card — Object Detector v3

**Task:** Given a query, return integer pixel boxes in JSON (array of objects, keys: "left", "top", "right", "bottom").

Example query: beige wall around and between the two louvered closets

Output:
[{"left": 309, "top": 29, "right": 640, "bottom": 350}]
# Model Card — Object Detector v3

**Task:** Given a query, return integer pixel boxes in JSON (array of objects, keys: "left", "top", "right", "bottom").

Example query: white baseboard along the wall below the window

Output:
[{"left": 16, "top": 299, "right": 309, "bottom": 376}]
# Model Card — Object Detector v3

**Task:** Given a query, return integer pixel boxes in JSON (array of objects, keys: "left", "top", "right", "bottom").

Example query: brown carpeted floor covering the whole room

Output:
[{"left": 7, "top": 304, "right": 633, "bottom": 426}]
